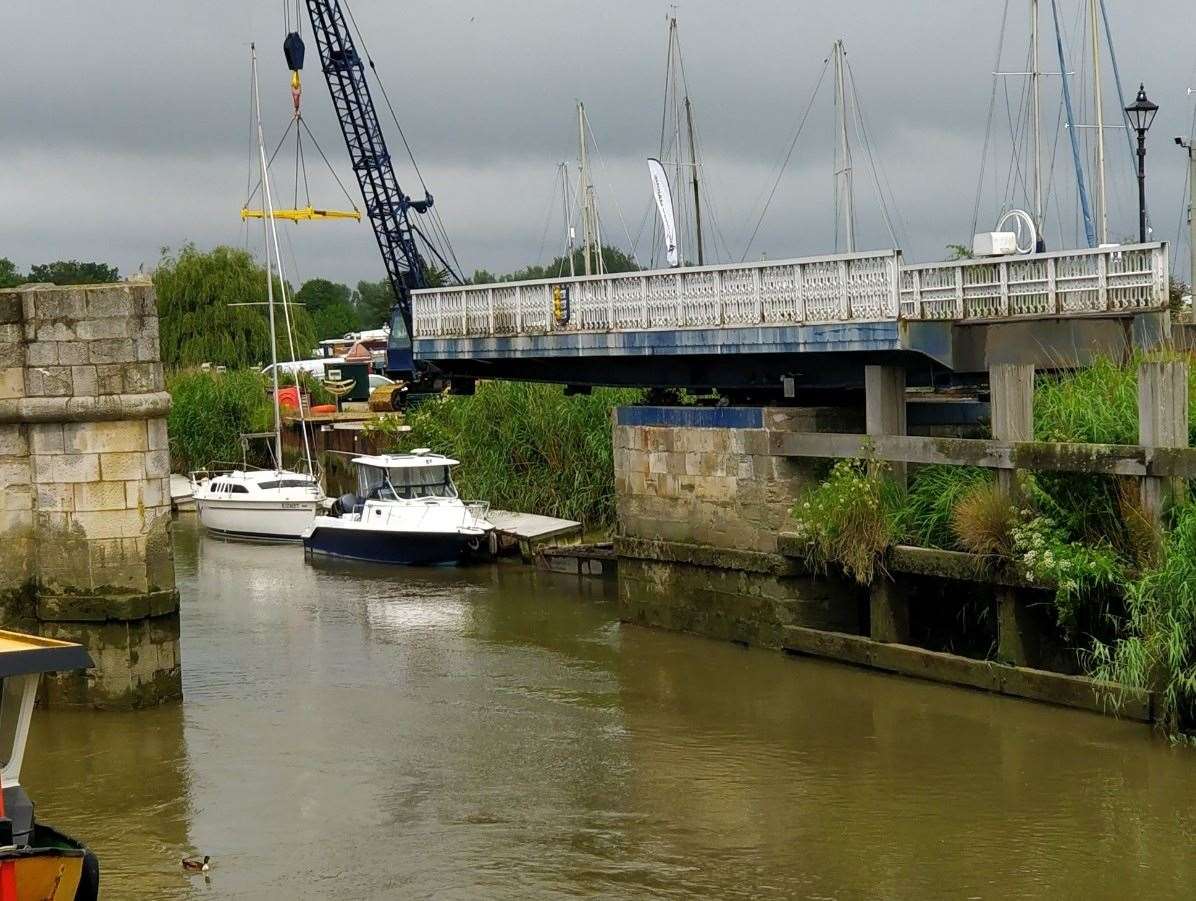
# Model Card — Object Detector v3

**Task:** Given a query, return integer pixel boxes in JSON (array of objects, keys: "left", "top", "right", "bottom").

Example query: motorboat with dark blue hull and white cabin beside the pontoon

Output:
[{"left": 303, "top": 448, "right": 494, "bottom": 565}]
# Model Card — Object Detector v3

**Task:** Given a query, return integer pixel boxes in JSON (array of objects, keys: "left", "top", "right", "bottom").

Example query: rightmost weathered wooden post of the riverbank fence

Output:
[{"left": 1137, "top": 363, "right": 1188, "bottom": 525}]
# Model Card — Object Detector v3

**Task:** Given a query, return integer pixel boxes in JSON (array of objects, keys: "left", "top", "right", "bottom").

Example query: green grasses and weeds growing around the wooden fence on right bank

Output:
[{"left": 793, "top": 359, "right": 1196, "bottom": 733}]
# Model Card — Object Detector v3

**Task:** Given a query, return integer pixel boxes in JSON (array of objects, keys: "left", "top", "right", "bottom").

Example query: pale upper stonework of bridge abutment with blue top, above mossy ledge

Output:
[{"left": 614, "top": 407, "right": 864, "bottom": 553}]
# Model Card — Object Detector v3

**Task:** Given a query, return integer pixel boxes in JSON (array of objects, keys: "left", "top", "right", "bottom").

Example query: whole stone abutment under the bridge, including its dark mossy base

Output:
[{"left": 614, "top": 407, "right": 867, "bottom": 647}]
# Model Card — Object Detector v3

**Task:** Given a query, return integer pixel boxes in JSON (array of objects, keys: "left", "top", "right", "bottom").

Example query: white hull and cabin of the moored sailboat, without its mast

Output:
[{"left": 191, "top": 469, "right": 324, "bottom": 541}]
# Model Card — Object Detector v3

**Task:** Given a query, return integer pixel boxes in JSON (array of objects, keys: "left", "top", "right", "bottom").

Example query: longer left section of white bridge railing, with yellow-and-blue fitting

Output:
[{"left": 411, "top": 250, "right": 901, "bottom": 337}]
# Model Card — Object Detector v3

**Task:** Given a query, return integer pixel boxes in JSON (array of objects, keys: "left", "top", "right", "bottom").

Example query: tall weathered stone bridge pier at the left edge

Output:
[{"left": 0, "top": 284, "right": 182, "bottom": 707}]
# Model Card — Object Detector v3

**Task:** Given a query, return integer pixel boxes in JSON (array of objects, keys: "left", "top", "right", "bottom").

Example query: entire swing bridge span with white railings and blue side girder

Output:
[{"left": 411, "top": 243, "right": 1170, "bottom": 394}]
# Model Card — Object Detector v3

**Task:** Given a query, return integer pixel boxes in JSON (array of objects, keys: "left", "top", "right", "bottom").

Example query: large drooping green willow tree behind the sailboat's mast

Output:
[{"left": 153, "top": 244, "right": 317, "bottom": 369}]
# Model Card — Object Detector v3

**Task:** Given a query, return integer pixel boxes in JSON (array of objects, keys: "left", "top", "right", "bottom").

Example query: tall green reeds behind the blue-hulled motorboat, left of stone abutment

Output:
[{"left": 375, "top": 382, "right": 640, "bottom": 529}]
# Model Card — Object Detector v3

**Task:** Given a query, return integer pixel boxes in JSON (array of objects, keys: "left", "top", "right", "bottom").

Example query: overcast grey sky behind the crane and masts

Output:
[{"left": 0, "top": 0, "right": 1196, "bottom": 282}]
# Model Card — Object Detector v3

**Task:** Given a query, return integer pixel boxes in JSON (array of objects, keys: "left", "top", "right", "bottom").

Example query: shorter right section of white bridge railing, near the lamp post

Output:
[{"left": 901, "top": 244, "right": 1170, "bottom": 322}]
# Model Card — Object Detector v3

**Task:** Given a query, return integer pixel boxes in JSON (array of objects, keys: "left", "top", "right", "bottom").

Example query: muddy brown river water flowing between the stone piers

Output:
[{"left": 16, "top": 523, "right": 1196, "bottom": 899}]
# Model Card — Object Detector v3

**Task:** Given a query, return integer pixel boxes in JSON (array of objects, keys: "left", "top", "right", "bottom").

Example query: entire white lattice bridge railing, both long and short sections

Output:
[{"left": 411, "top": 244, "right": 1168, "bottom": 339}]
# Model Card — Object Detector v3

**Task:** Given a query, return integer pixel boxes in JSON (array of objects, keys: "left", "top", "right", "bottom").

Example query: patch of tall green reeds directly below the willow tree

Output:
[{"left": 166, "top": 370, "right": 274, "bottom": 473}]
